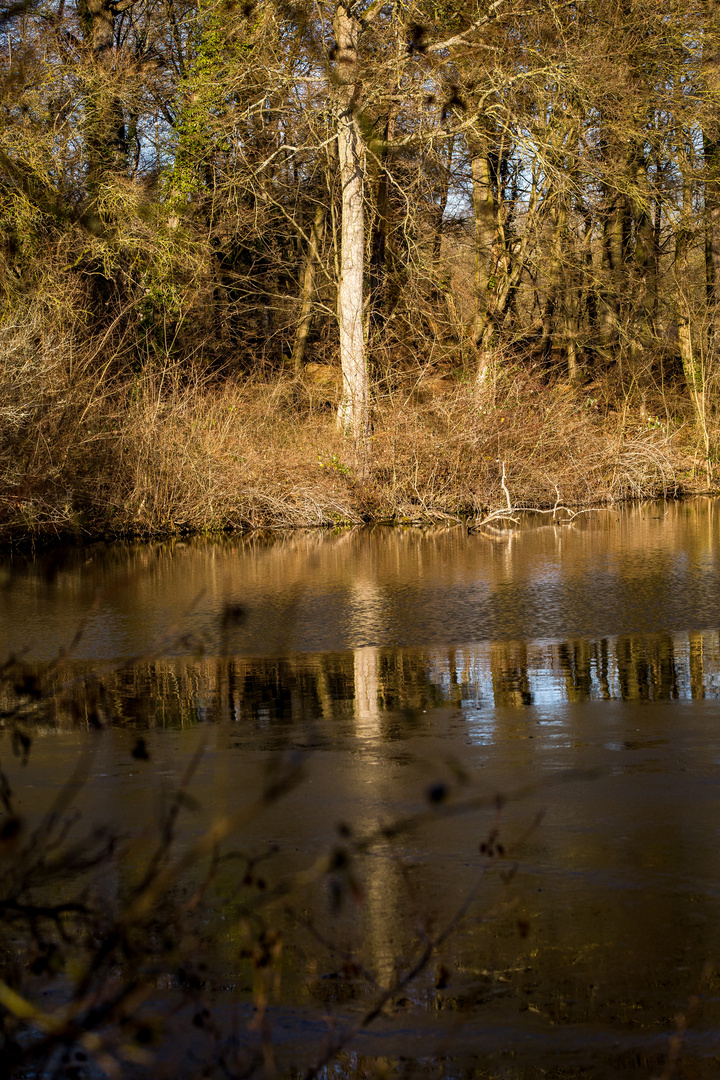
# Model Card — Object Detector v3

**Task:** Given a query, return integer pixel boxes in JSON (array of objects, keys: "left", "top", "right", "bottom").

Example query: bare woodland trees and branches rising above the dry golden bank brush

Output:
[{"left": 0, "top": 0, "right": 720, "bottom": 531}]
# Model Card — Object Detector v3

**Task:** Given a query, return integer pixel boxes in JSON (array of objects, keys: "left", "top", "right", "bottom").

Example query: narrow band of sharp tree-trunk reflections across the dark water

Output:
[{"left": 27, "top": 631, "right": 720, "bottom": 737}]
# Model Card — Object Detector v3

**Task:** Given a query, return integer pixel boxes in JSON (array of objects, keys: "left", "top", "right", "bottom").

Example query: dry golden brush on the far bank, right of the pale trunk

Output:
[{"left": 362, "top": 370, "right": 694, "bottom": 517}]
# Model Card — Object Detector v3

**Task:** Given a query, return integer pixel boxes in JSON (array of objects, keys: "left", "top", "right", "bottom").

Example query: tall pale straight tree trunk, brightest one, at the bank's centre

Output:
[{"left": 332, "top": 4, "right": 370, "bottom": 443}]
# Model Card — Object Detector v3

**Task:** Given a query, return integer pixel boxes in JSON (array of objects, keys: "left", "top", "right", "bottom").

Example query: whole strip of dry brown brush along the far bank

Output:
[{"left": 0, "top": 360, "right": 714, "bottom": 542}]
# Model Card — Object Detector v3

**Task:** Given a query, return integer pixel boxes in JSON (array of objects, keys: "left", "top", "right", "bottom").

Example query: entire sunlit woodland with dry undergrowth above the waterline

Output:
[{"left": 0, "top": 0, "right": 720, "bottom": 539}]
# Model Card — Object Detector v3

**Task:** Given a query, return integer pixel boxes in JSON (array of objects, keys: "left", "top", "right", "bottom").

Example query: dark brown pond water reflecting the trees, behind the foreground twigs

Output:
[{"left": 0, "top": 499, "right": 720, "bottom": 1078}]
